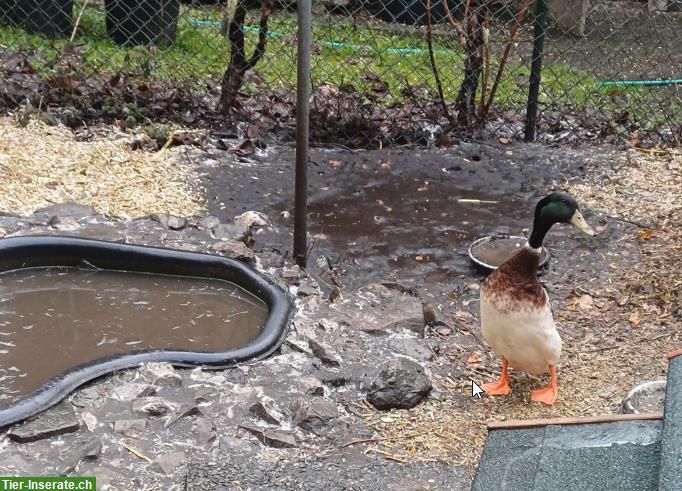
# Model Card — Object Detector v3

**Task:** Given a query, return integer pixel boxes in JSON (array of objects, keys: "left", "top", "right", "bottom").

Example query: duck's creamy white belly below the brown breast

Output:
[{"left": 481, "top": 288, "right": 561, "bottom": 375}]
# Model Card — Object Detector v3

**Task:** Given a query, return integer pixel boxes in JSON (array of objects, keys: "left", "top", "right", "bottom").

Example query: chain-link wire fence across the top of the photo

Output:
[{"left": 0, "top": 0, "right": 682, "bottom": 146}]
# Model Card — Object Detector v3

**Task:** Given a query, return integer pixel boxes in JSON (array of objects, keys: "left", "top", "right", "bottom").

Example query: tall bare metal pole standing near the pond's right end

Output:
[{"left": 294, "top": 0, "right": 312, "bottom": 268}]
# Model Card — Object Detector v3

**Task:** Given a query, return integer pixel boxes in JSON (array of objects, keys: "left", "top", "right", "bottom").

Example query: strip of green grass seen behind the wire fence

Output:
[{"left": 0, "top": 1, "right": 682, "bottom": 125}]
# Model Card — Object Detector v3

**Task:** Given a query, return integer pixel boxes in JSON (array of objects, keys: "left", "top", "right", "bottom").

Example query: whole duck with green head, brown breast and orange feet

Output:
[{"left": 480, "top": 192, "right": 595, "bottom": 406}]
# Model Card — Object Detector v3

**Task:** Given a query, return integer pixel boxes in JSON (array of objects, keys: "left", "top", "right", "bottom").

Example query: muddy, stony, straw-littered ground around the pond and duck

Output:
[{"left": 0, "top": 136, "right": 682, "bottom": 490}]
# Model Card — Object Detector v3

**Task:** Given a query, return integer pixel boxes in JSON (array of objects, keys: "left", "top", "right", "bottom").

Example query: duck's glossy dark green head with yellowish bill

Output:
[{"left": 528, "top": 192, "right": 594, "bottom": 248}]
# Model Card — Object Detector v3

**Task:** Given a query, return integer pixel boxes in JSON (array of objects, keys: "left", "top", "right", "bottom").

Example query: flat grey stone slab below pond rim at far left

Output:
[{"left": 8, "top": 401, "right": 80, "bottom": 443}]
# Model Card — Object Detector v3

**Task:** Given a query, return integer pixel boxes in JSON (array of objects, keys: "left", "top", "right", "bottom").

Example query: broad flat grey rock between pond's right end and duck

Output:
[{"left": 333, "top": 284, "right": 426, "bottom": 337}]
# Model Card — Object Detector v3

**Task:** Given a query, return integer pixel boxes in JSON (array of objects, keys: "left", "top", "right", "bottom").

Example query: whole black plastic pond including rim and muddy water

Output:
[{"left": 0, "top": 236, "right": 292, "bottom": 426}]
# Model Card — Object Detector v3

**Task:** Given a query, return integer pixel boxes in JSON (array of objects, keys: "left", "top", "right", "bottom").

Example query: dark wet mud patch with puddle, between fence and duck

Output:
[{"left": 206, "top": 145, "right": 553, "bottom": 292}]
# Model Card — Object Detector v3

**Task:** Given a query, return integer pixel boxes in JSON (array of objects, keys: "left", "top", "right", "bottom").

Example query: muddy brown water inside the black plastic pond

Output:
[{"left": 0, "top": 268, "right": 268, "bottom": 407}]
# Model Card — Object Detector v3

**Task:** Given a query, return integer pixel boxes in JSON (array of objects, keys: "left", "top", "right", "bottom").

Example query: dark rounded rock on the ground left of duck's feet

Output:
[{"left": 367, "top": 358, "right": 432, "bottom": 409}]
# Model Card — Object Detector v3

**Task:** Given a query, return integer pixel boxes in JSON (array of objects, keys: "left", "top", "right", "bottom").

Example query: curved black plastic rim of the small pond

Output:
[{"left": 0, "top": 236, "right": 293, "bottom": 427}]
